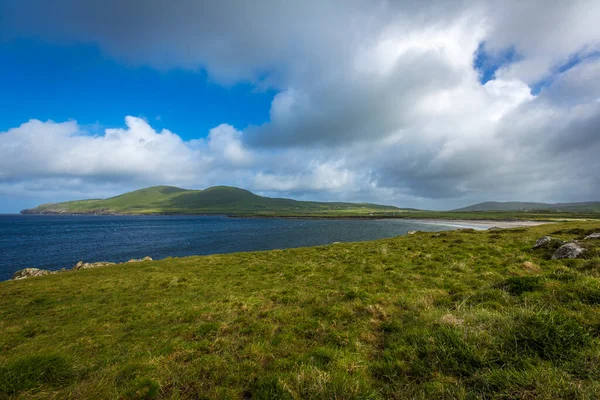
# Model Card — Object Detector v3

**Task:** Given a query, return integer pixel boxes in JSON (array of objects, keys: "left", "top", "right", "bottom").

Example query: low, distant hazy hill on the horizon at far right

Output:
[{"left": 452, "top": 201, "right": 600, "bottom": 212}]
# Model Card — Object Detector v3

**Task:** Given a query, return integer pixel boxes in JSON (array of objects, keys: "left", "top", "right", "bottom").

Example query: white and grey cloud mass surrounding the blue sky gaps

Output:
[{"left": 0, "top": 0, "right": 600, "bottom": 208}]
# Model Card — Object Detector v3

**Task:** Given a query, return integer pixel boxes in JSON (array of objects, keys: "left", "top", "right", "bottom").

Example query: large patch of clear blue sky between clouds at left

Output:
[{"left": 0, "top": 39, "right": 274, "bottom": 140}]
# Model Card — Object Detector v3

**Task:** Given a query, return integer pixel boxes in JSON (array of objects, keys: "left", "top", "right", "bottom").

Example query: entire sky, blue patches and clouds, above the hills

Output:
[{"left": 0, "top": 0, "right": 600, "bottom": 213}]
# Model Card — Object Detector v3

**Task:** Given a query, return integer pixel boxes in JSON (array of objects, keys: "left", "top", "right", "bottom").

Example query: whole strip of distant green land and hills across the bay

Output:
[{"left": 21, "top": 186, "right": 600, "bottom": 221}]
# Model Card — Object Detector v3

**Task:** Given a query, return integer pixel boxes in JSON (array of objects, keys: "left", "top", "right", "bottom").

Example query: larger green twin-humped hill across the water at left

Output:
[{"left": 21, "top": 186, "right": 401, "bottom": 216}]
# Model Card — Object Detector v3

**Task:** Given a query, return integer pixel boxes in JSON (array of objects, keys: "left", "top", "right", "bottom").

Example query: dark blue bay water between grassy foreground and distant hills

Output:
[{"left": 0, "top": 215, "right": 480, "bottom": 281}]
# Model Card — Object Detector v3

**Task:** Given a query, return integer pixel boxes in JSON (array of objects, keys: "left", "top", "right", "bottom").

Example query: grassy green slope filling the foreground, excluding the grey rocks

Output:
[{"left": 0, "top": 222, "right": 600, "bottom": 399}]
